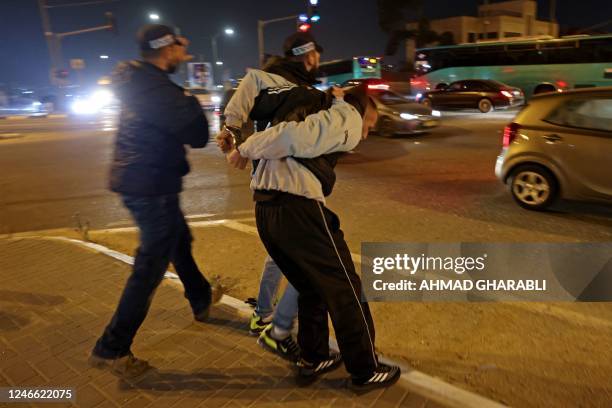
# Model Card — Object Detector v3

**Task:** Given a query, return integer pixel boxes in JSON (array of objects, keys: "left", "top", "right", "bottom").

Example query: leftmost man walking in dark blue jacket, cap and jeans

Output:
[{"left": 90, "top": 25, "right": 218, "bottom": 377}]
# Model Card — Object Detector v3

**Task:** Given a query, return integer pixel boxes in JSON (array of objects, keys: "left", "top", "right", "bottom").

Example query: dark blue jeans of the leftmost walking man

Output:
[{"left": 93, "top": 194, "right": 212, "bottom": 358}]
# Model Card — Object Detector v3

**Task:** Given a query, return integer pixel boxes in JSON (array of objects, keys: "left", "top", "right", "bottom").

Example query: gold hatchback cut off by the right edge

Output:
[{"left": 495, "top": 87, "right": 612, "bottom": 210}]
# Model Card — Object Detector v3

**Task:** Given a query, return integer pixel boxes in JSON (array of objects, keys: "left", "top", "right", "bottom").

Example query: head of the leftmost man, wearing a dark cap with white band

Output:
[{"left": 137, "top": 24, "right": 190, "bottom": 74}]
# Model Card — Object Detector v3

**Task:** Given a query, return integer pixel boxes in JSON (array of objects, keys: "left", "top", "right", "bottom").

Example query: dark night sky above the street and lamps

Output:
[{"left": 0, "top": 0, "right": 612, "bottom": 87}]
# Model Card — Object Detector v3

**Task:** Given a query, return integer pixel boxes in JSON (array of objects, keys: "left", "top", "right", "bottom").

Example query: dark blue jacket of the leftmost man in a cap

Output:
[{"left": 110, "top": 61, "right": 209, "bottom": 196}]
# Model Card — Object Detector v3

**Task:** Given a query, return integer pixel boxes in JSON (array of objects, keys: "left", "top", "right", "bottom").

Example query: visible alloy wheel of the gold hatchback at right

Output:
[{"left": 509, "top": 164, "right": 559, "bottom": 211}]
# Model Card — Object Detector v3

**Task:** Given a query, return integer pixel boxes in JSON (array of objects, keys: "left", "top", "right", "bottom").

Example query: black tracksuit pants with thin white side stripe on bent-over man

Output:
[{"left": 255, "top": 193, "right": 377, "bottom": 377}]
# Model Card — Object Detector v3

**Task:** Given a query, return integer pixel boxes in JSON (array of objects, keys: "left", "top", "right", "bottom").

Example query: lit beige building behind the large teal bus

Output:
[{"left": 406, "top": 0, "right": 559, "bottom": 61}]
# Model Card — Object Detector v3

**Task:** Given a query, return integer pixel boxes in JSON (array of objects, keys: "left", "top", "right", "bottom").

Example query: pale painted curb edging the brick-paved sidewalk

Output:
[{"left": 28, "top": 236, "right": 506, "bottom": 408}]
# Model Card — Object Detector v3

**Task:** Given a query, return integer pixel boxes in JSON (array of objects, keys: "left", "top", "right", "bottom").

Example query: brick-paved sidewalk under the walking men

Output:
[{"left": 0, "top": 238, "right": 450, "bottom": 408}]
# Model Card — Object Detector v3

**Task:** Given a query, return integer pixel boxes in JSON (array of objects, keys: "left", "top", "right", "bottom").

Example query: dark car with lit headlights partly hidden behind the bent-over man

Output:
[{"left": 368, "top": 84, "right": 441, "bottom": 137}]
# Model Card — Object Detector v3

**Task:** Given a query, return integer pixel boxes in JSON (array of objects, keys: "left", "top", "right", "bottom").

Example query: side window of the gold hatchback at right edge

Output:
[{"left": 546, "top": 98, "right": 612, "bottom": 132}]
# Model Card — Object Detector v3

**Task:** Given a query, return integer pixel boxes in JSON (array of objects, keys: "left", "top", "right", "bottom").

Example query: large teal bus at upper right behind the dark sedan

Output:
[{"left": 410, "top": 35, "right": 612, "bottom": 99}]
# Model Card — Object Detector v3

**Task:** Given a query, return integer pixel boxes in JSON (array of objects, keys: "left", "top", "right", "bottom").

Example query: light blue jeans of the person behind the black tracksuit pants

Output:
[{"left": 255, "top": 255, "right": 299, "bottom": 330}]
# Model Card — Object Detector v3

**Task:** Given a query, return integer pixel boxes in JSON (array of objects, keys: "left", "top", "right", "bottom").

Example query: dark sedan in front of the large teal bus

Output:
[{"left": 417, "top": 79, "right": 525, "bottom": 113}]
